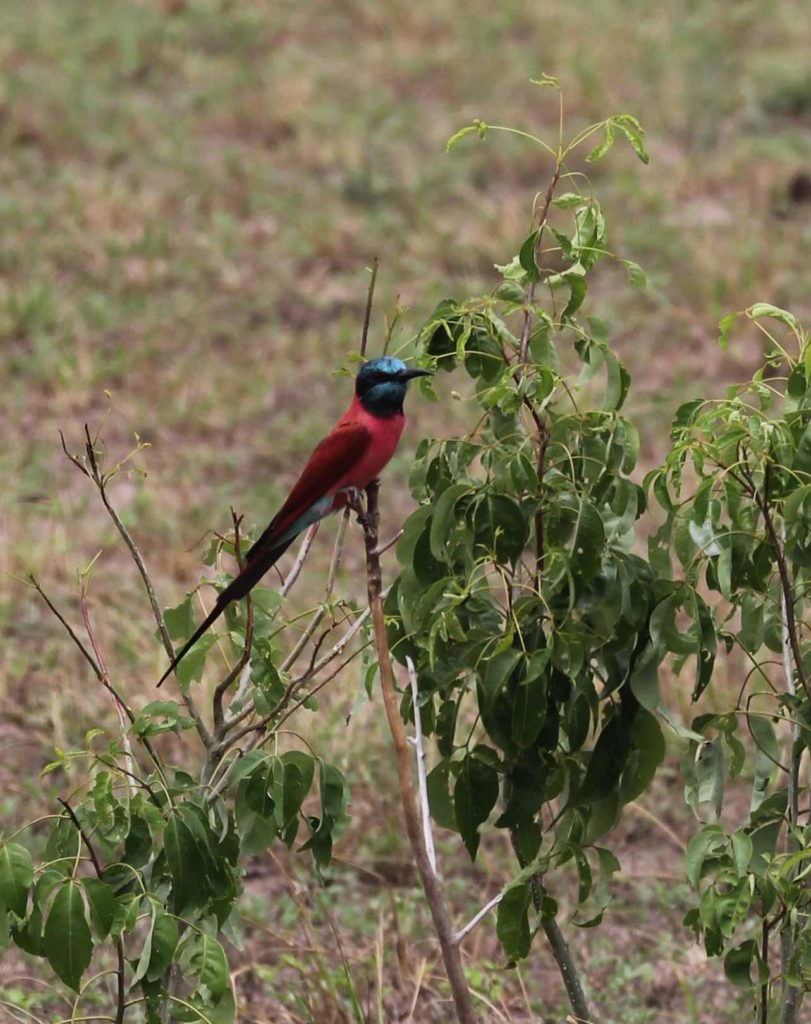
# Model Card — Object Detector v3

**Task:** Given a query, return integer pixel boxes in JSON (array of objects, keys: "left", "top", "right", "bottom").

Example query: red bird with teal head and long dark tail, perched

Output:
[{"left": 158, "top": 355, "right": 431, "bottom": 686}]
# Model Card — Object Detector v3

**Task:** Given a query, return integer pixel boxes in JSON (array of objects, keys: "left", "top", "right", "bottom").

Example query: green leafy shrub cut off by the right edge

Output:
[{"left": 647, "top": 303, "right": 811, "bottom": 1014}]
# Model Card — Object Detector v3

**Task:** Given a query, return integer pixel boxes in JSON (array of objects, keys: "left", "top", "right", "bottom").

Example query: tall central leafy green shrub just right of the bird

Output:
[{"left": 386, "top": 97, "right": 663, "bottom": 959}]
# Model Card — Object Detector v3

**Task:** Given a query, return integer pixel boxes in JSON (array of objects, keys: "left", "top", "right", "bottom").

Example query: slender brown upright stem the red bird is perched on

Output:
[{"left": 350, "top": 480, "right": 476, "bottom": 1024}]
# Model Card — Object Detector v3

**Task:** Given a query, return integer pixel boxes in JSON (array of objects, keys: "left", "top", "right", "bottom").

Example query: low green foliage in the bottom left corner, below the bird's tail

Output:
[{"left": 7, "top": 479, "right": 353, "bottom": 1024}]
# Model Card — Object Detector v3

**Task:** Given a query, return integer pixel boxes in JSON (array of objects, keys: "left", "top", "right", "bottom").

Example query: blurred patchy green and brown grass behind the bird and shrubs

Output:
[{"left": 0, "top": 0, "right": 811, "bottom": 1022}]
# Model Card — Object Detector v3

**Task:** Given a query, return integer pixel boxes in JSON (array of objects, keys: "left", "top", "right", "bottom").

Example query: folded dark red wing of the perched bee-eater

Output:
[{"left": 246, "top": 423, "right": 372, "bottom": 563}]
